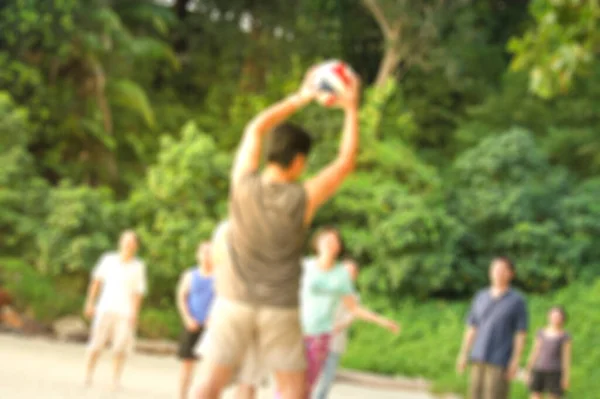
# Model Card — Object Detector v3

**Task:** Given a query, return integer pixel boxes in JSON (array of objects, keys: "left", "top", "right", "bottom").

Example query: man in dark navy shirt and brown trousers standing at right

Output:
[{"left": 457, "top": 257, "right": 528, "bottom": 399}]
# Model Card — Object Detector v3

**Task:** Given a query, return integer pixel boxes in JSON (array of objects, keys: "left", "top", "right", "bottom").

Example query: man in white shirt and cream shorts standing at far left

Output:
[{"left": 84, "top": 230, "right": 147, "bottom": 389}]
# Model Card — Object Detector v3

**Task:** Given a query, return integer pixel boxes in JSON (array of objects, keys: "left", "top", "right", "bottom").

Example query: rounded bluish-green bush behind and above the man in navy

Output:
[{"left": 448, "top": 129, "right": 593, "bottom": 290}]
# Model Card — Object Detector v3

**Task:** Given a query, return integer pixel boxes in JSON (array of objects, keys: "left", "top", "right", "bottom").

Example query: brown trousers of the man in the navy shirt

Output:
[{"left": 469, "top": 363, "right": 510, "bottom": 399}]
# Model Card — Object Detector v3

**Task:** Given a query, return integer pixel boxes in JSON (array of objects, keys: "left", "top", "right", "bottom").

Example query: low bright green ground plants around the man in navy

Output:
[{"left": 343, "top": 281, "right": 600, "bottom": 398}]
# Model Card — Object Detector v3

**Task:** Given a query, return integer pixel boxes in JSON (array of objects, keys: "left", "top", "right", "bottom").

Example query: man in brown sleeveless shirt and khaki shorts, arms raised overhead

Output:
[{"left": 196, "top": 65, "right": 360, "bottom": 399}]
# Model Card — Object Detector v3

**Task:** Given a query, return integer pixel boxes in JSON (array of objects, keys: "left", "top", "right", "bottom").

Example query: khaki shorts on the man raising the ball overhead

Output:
[{"left": 201, "top": 297, "right": 306, "bottom": 380}]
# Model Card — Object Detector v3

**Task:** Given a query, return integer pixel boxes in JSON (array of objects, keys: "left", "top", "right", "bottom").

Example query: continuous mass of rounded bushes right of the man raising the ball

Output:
[{"left": 316, "top": 128, "right": 599, "bottom": 297}]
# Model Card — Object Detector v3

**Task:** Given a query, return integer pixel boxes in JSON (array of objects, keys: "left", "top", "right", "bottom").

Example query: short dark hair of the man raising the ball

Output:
[{"left": 267, "top": 123, "right": 312, "bottom": 168}]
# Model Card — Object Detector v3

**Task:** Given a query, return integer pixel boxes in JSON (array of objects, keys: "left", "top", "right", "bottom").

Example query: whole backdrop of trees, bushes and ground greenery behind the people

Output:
[{"left": 0, "top": 0, "right": 600, "bottom": 398}]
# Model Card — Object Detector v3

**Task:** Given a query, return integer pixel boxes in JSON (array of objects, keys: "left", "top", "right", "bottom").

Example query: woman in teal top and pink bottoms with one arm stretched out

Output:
[{"left": 300, "top": 227, "right": 399, "bottom": 397}]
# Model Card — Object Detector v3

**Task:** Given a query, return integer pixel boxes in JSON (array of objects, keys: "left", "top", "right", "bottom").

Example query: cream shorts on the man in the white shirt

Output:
[{"left": 88, "top": 313, "right": 134, "bottom": 353}]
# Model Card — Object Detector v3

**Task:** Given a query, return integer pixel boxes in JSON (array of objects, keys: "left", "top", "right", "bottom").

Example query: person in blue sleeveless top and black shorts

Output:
[{"left": 177, "top": 242, "right": 214, "bottom": 399}]
